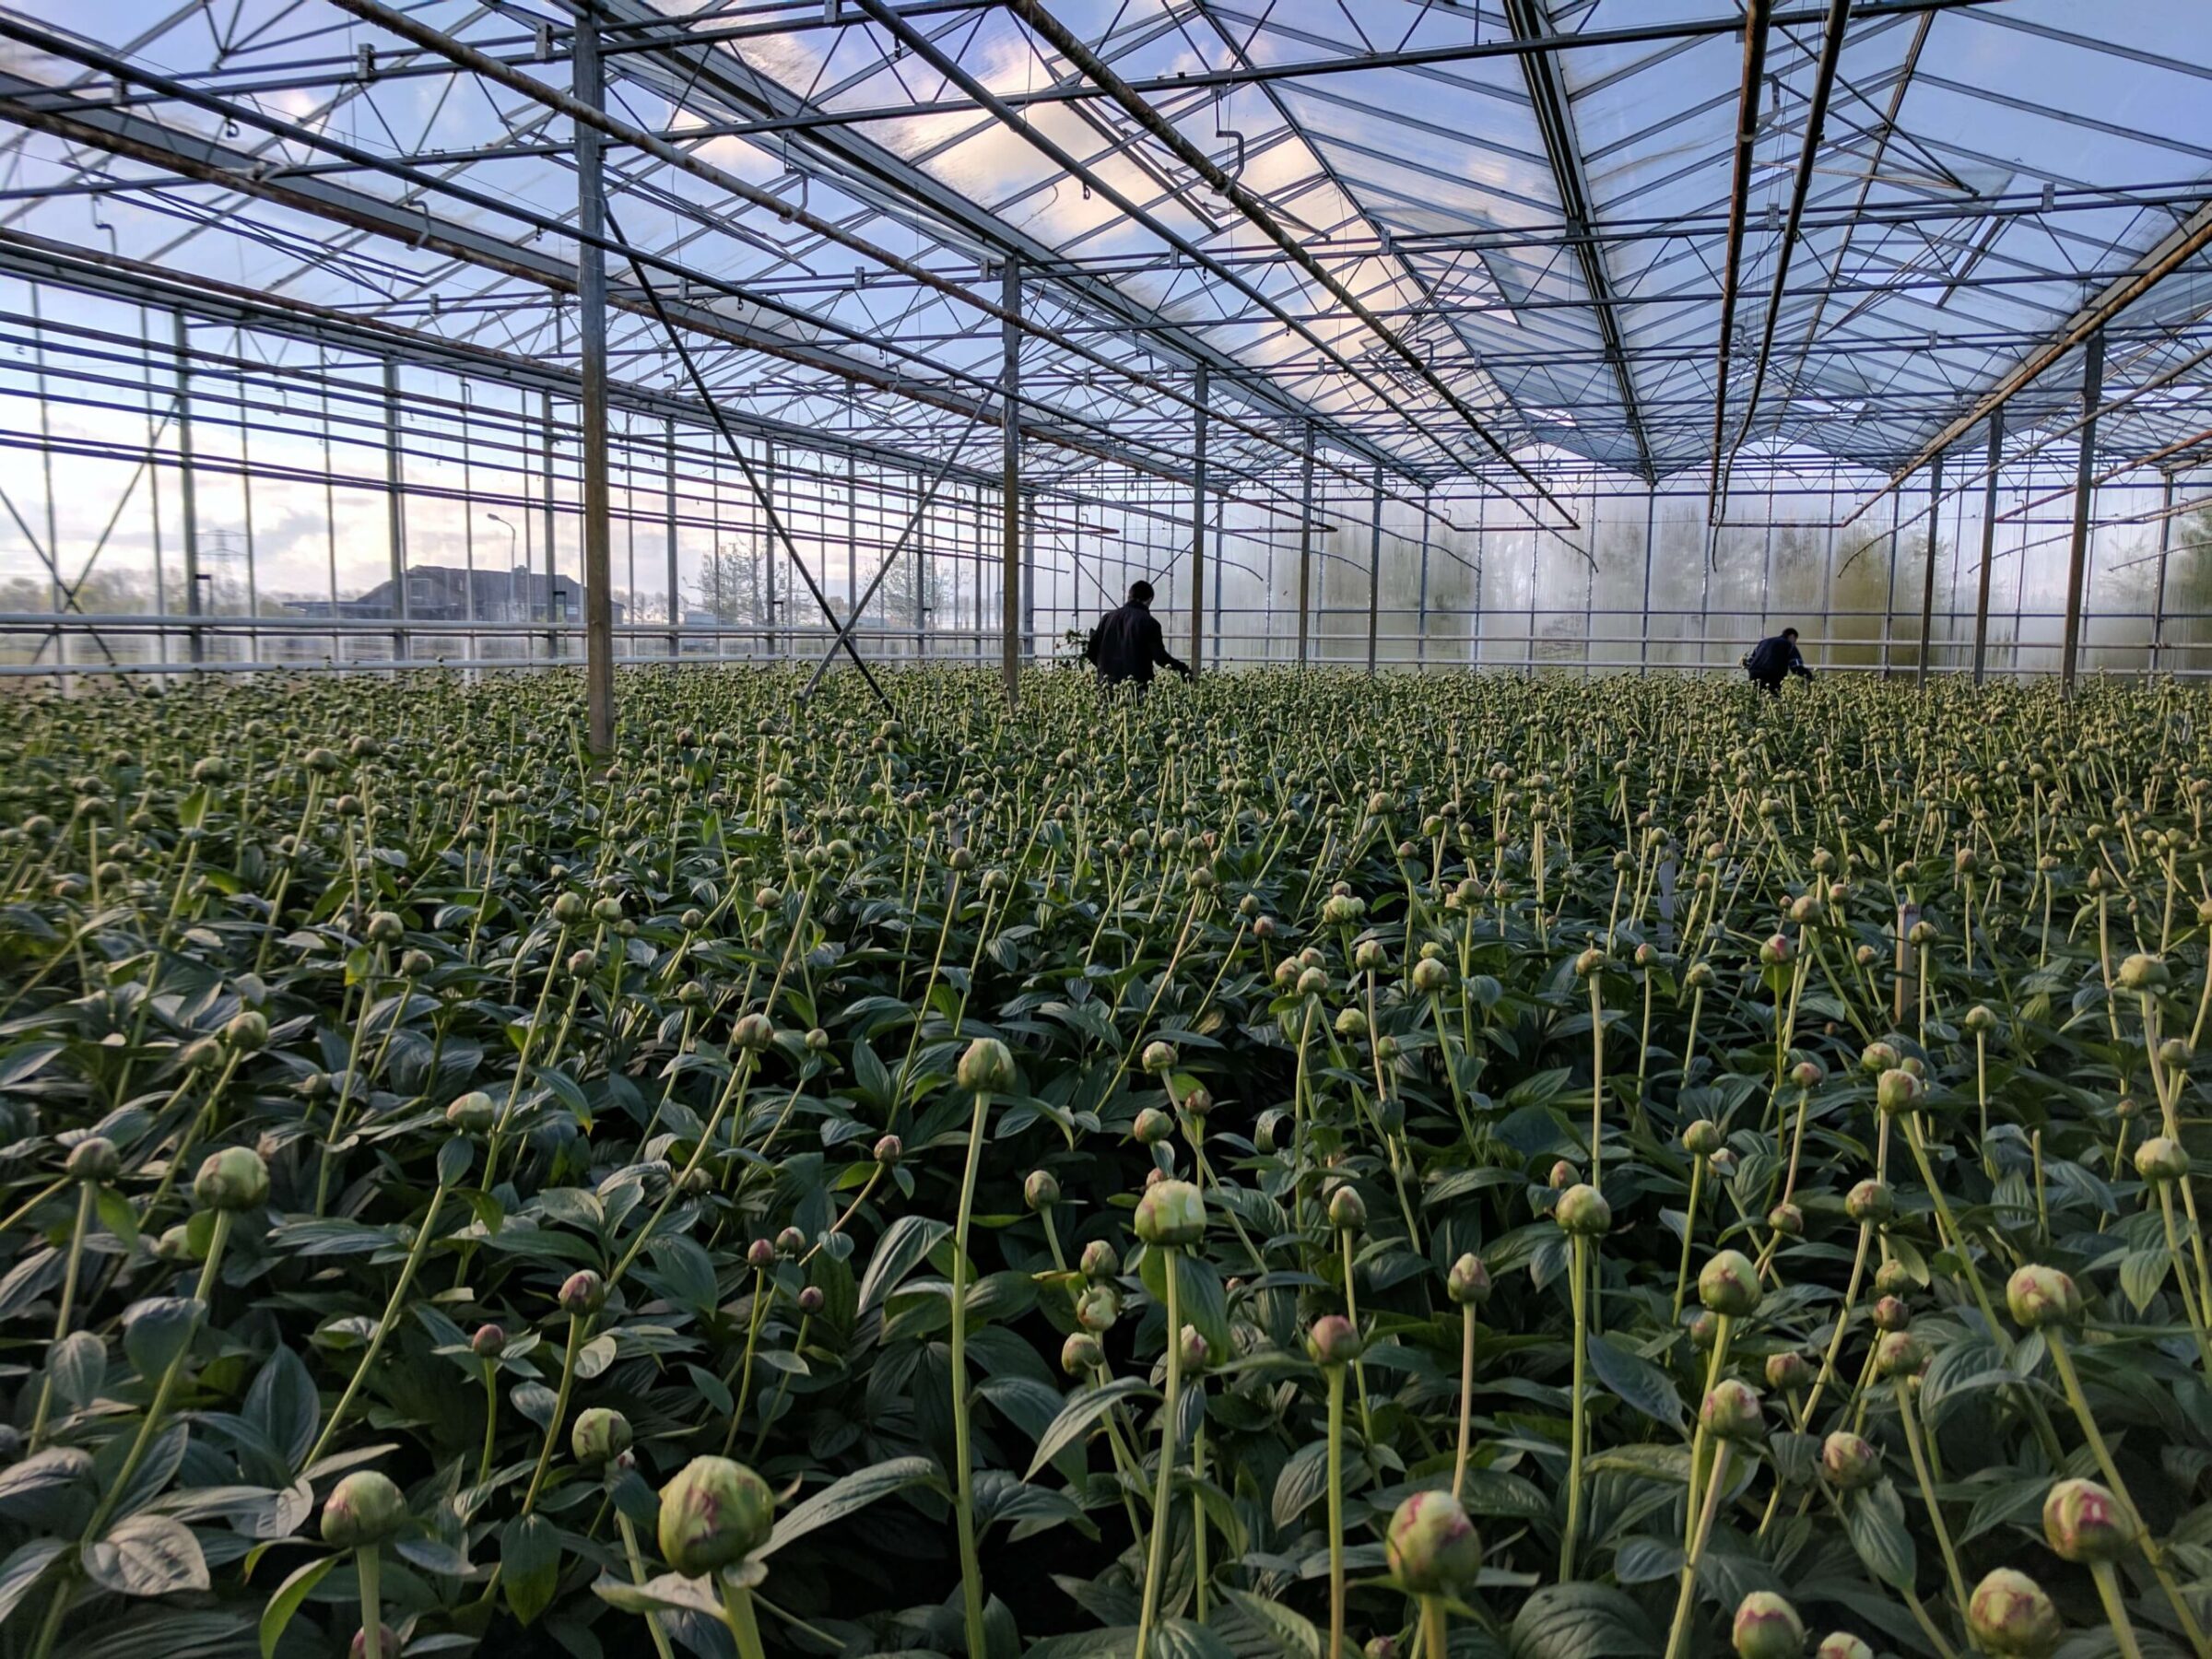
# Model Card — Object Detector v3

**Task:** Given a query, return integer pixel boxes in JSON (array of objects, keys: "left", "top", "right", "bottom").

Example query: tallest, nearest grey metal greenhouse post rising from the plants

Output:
[{"left": 569, "top": 0, "right": 615, "bottom": 757}]
